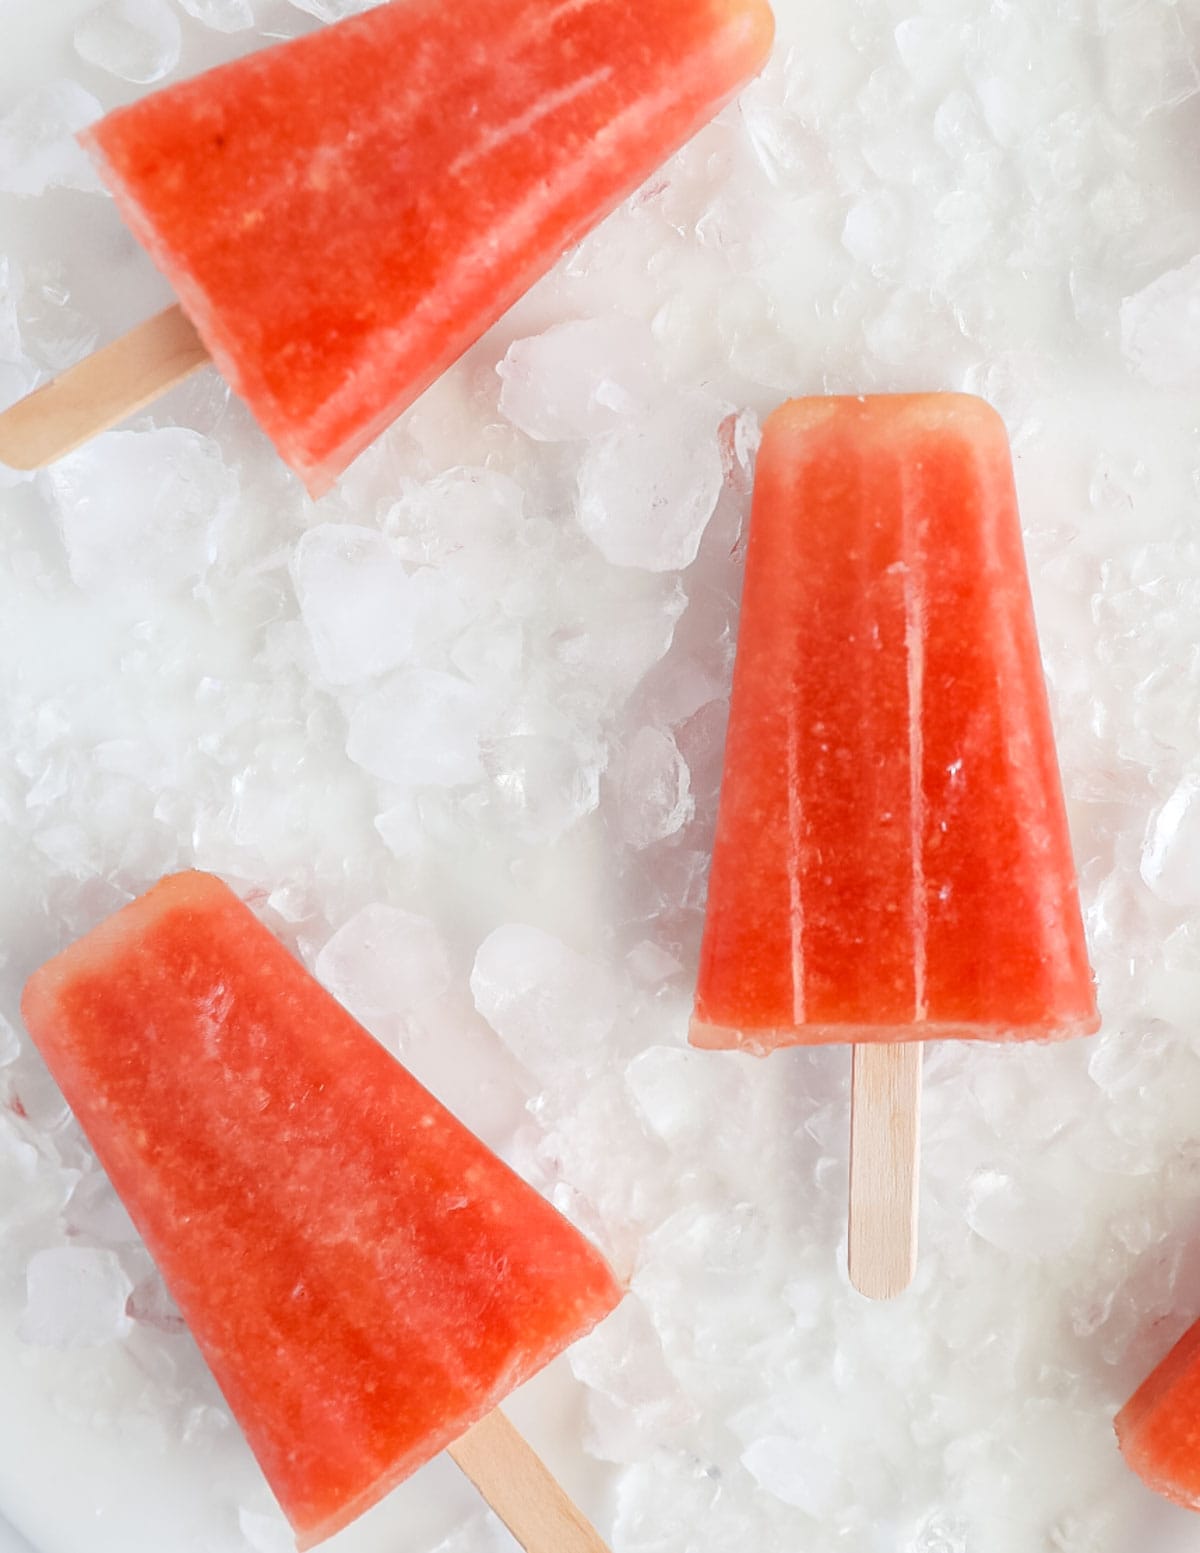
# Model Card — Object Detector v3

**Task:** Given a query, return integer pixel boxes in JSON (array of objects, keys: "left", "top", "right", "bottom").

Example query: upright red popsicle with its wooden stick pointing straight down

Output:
[{"left": 691, "top": 394, "right": 1098, "bottom": 1292}]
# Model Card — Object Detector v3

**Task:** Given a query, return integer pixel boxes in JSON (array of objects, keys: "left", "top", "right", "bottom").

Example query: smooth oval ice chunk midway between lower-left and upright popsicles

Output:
[{"left": 470, "top": 922, "right": 616, "bottom": 1081}]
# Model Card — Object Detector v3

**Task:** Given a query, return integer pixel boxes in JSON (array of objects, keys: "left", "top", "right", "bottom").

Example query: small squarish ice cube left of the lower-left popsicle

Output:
[{"left": 19, "top": 1246, "right": 134, "bottom": 1348}]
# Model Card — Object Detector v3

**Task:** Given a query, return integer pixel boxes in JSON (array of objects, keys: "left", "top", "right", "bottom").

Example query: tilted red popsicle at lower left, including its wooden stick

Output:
[{"left": 22, "top": 873, "right": 621, "bottom": 1553}]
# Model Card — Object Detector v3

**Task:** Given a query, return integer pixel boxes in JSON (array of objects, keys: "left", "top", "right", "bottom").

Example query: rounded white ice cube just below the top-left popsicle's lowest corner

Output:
[{"left": 292, "top": 523, "right": 414, "bottom": 685}]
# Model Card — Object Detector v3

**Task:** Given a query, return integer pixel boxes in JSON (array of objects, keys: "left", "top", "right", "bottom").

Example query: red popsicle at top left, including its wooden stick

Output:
[{"left": 0, "top": 0, "right": 773, "bottom": 494}]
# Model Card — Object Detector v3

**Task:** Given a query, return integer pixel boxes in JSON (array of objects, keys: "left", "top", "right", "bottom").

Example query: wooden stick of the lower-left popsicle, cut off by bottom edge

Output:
[{"left": 449, "top": 1410, "right": 609, "bottom": 1553}]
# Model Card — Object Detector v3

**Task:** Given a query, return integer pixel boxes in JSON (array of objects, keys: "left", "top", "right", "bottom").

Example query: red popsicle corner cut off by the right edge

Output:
[{"left": 1115, "top": 1322, "right": 1200, "bottom": 1510}]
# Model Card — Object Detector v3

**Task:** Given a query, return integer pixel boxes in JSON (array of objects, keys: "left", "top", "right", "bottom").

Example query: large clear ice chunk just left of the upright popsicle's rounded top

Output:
[{"left": 579, "top": 391, "right": 728, "bottom": 572}]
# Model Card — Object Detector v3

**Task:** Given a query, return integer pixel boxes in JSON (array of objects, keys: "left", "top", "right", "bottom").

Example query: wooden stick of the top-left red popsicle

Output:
[{"left": 0, "top": 306, "right": 208, "bottom": 469}]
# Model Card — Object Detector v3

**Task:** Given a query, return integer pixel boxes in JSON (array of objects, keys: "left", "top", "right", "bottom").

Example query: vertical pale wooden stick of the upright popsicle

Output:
[{"left": 849, "top": 1041, "right": 922, "bottom": 1300}]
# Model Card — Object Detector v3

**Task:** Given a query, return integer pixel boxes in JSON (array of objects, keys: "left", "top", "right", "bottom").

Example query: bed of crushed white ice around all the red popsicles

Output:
[{"left": 0, "top": 0, "right": 1200, "bottom": 1553}]
